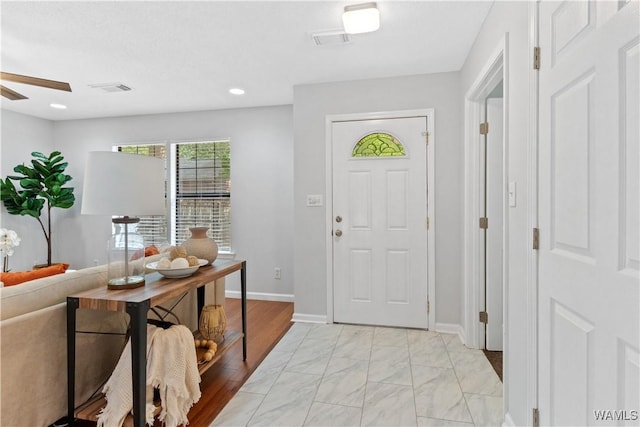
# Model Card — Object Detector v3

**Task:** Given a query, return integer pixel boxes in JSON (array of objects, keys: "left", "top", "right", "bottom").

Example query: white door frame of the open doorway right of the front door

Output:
[{"left": 464, "top": 34, "right": 509, "bottom": 352}]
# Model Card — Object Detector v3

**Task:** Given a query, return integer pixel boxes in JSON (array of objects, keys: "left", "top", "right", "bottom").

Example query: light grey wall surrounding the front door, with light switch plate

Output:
[{"left": 293, "top": 73, "right": 463, "bottom": 325}]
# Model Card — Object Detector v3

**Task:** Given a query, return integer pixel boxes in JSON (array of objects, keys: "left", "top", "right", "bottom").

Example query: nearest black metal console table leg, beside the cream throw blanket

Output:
[{"left": 127, "top": 300, "right": 151, "bottom": 427}]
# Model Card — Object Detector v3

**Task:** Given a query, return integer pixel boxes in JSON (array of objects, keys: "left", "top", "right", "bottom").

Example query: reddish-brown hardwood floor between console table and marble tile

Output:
[{"left": 60, "top": 298, "right": 293, "bottom": 427}]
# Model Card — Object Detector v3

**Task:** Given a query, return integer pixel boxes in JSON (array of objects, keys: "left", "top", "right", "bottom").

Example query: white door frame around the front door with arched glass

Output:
[{"left": 325, "top": 108, "right": 436, "bottom": 329}]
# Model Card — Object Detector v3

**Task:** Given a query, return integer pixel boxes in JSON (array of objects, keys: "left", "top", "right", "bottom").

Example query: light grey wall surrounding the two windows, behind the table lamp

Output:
[{"left": 2, "top": 106, "right": 293, "bottom": 295}]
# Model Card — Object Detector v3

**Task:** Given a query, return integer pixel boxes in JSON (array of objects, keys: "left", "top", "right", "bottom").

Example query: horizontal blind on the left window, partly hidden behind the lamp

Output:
[{"left": 118, "top": 144, "right": 169, "bottom": 247}]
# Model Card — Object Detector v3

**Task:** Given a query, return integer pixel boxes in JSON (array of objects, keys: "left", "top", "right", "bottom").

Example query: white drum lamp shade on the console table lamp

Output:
[{"left": 81, "top": 151, "right": 165, "bottom": 217}]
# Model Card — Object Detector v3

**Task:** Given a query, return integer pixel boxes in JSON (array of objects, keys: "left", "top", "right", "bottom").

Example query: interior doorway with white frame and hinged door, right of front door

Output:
[{"left": 464, "top": 38, "right": 508, "bottom": 386}]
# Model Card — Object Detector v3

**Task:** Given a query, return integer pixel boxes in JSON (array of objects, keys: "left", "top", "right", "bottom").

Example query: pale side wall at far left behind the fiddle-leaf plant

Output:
[{"left": 0, "top": 110, "right": 55, "bottom": 271}]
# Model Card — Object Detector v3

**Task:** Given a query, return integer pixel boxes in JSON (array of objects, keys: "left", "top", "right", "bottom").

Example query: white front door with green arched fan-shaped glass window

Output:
[{"left": 332, "top": 117, "right": 428, "bottom": 328}]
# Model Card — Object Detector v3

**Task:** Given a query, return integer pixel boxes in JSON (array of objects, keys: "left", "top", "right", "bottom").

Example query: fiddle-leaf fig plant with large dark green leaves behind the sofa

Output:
[{"left": 0, "top": 151, "right": 76, "bottom": 265}]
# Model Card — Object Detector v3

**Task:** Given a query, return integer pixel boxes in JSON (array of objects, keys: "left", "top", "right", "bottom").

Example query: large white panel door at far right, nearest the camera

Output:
[{"left": 538, "top": 1, "right": 640, "bottom": 426}]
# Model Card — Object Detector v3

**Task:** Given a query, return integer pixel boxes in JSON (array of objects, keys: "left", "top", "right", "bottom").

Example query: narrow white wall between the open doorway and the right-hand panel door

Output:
[{"left": 461, "top": 2, "right": 535, "bottom": 425}]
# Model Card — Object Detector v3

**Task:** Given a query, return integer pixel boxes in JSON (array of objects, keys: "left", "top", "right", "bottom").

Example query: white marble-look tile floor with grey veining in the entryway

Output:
[{"left": 212, "top": 323, "right": 503, "bottom": 427}]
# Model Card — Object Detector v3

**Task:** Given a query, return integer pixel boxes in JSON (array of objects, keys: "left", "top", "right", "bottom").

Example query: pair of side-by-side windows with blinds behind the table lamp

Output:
[{"left": 118, "top": 140, "right": 231, "bottom": 252}]
